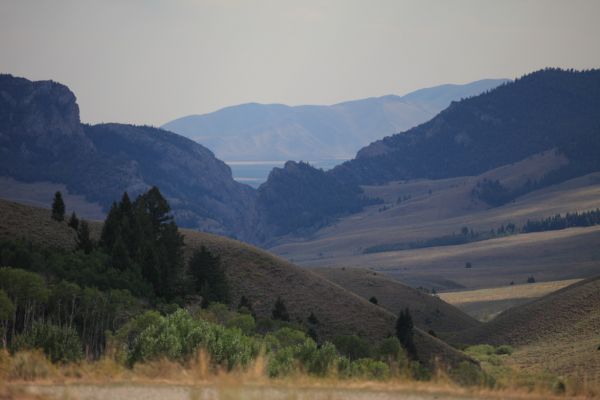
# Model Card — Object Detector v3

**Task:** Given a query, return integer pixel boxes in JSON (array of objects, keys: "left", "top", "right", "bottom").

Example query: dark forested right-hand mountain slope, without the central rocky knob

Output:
[{"left": 332, "top": 69, "right": 600, "bottom": 184}]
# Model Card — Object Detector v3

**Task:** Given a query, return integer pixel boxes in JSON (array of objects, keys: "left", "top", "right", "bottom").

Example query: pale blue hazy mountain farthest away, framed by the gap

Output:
[{"left": 163, "top": 79, "right": 506, "bottom": 160}]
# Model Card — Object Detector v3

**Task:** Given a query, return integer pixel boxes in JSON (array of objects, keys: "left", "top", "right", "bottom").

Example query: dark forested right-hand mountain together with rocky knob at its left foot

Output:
[{"left": 258, "top": 69, "right": 600, "bottom": 236}]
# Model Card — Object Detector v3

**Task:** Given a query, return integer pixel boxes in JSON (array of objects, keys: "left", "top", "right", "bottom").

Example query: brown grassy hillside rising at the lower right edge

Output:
[{"left": 454, "top": 277, "right": 600, "bottom": 383}]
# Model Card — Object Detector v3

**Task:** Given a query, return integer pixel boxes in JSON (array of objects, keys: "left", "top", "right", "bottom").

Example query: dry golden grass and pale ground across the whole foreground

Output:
[{"left": 0, "top": 345, "right": 600, "bottom": 400}]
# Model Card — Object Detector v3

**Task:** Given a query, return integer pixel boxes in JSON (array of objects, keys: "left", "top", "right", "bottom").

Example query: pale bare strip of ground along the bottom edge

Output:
[{"left": 7, "top": 382, "right": 576, "bottom": 400}]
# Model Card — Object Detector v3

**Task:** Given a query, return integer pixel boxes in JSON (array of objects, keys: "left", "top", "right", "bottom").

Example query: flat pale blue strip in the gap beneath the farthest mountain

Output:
[{"left": 225, "top": 159, "right": 346, "bottom": 188}]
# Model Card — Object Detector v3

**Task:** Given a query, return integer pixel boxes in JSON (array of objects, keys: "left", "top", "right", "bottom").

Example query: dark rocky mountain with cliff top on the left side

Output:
[{"left": 0, "top": 75, "right": 257, "bottom": 240}]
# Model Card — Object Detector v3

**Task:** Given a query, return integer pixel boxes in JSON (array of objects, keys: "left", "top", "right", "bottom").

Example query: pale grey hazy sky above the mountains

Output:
[{"left": 0, "top": 0, "right": 600, "bottom": 125}]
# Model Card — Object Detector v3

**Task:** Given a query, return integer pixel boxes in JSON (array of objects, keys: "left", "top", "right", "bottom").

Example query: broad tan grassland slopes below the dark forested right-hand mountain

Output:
[{"left": 270, "top": 154, "right": 600, "bottom": 289}]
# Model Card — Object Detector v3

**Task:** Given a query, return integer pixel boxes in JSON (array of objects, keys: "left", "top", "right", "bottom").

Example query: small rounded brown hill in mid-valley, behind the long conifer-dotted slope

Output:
[{"left": 315, "top": 268, "right": 479, "bottom": 333}]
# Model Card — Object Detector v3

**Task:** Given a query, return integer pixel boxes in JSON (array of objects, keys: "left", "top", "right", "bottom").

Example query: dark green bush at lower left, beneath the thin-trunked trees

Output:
[{"left": 12, "top": 322, "right": 83, "bottom": 362}]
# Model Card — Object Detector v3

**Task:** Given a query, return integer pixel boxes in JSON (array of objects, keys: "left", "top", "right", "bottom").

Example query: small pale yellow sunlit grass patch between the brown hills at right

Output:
[{"left": 439, "top": 279, "right": 580, "bottom": 321}]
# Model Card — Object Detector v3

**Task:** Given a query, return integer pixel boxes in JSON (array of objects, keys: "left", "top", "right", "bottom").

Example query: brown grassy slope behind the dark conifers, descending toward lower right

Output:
[{"left": 0, "top": 200, "right": 468, "bottom": 365}]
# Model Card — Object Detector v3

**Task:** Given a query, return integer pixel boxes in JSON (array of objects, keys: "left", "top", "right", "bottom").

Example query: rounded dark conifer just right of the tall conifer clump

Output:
[{"left": 188, "top": 246, "right": 230, "bottom": 306}]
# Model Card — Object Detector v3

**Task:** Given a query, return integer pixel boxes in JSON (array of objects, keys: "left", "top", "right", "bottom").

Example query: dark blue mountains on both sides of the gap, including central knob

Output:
[{"left": 0, "top": 69, "right": 600, "bottom": 244}]
